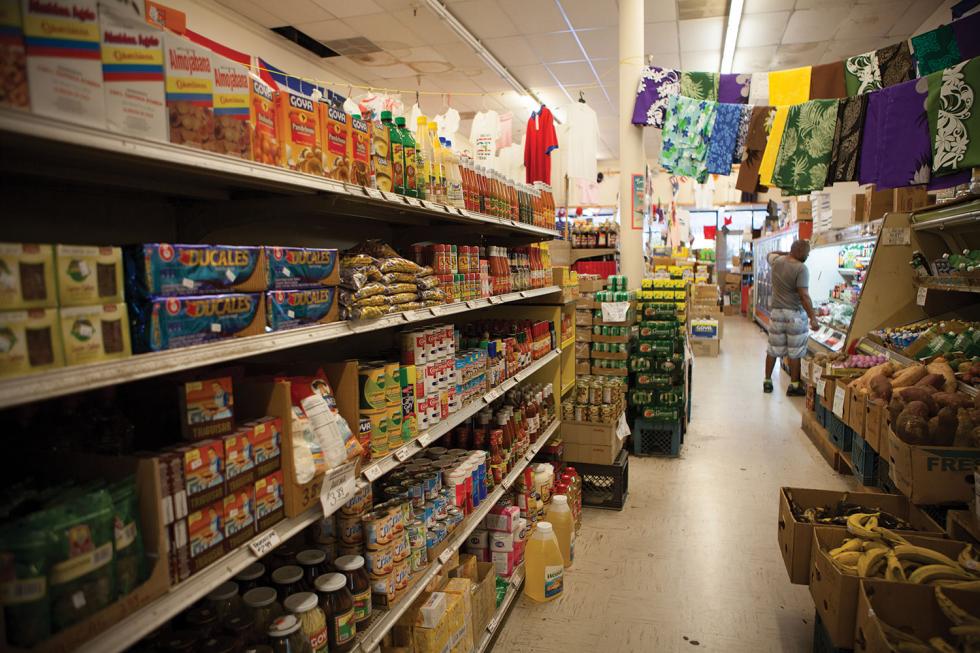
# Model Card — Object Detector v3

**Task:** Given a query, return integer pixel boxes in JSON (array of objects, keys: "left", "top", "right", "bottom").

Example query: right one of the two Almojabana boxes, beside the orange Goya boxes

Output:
[{"left": 211, "top": 54, "right": 252, "bottom": 159}]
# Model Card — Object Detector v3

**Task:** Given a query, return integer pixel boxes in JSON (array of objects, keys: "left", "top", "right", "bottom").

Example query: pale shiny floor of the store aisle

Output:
[{"left": 494, "top": 317, "right": 856, "bottom": 653}]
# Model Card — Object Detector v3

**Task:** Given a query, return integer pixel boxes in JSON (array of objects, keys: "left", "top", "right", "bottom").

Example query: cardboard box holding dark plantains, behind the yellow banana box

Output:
[{"left": 776, "top": 487, "right": 945, "bottom": 585}]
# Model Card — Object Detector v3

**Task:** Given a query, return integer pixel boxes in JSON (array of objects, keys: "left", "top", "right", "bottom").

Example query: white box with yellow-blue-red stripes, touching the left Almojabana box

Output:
[{"left": 99, "top": 6, "right": 169, "bottom": 141}]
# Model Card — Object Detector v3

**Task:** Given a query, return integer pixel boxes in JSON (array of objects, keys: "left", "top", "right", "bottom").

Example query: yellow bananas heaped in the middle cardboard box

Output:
[{"left": 827, "top": 513, "right": 980, "bottom": 589}]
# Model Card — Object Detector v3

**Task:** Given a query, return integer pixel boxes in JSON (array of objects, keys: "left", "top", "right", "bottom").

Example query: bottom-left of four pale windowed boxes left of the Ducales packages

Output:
[{"left": 0, "top": 308, "right": 65, "bottom": 376}]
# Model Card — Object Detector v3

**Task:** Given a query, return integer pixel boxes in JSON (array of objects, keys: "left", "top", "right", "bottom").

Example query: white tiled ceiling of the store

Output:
[{"left": 218, "top": 0, "right": 944, "bottom": 158}]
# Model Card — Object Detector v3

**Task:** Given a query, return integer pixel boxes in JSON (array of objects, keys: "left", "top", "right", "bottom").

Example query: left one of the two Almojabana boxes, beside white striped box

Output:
[{"left": 163, "top": 32, "right": 214, "bottom": 150}]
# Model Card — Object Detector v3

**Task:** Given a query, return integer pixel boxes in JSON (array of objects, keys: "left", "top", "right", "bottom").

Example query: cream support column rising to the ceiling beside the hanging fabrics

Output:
[{"left": 619, "top": 0, "right": 646, "bottom": 288}]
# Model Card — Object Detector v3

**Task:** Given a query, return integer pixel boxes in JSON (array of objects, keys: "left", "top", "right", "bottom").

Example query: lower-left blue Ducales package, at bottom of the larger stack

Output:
[{"left": 130, "top": 293, "right": 265, "bottom": 353}]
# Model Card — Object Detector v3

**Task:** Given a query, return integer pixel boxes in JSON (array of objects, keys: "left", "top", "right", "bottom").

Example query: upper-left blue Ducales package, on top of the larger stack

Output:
[{"left": 126, "top": 243, "right": 268, "bottom": 297}]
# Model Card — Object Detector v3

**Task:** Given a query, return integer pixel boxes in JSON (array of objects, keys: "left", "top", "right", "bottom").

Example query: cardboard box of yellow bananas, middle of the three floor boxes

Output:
[{"left": 810, "top": 513, "right": 980, "bottom": 650}]
